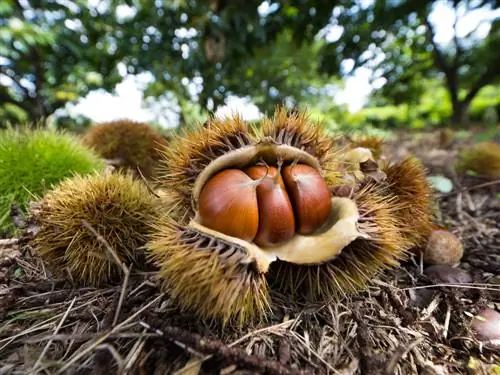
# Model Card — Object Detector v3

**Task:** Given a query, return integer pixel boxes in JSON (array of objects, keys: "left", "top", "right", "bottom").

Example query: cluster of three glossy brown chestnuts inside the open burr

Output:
[{"left": 199, "top": 163, "right": 332, "bottom": 248}]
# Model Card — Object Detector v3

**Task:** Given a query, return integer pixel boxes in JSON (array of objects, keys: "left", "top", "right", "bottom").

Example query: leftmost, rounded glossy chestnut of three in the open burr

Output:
[{"left": 199, "top": 169, "right": 261, "bottom": 241}]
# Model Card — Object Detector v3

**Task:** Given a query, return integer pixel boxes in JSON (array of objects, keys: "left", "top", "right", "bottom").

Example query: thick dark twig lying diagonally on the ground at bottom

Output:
[{"left": 138, "top": 322, "right": 309, "bottom": 375}]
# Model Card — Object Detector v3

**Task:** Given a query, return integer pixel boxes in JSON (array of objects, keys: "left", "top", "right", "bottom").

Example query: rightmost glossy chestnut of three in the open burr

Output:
[{"left": 283, "top": 164, "right": 332, "bottom": 234}]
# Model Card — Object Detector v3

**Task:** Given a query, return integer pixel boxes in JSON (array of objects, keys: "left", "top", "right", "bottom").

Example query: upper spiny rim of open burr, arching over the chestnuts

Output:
[{"left": 156, "top": 110, "right": 340, "bottom": 223}]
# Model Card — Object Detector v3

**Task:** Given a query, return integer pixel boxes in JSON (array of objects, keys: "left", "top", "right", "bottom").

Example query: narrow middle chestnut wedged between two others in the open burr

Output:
[{"left": 245, "top": 166, "right": 295, "bottom": 247}]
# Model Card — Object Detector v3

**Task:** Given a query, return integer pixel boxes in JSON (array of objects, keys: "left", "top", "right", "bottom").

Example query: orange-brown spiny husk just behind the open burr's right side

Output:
[{"left": 382, "top": 156, "right": 433, "bottom": 247}]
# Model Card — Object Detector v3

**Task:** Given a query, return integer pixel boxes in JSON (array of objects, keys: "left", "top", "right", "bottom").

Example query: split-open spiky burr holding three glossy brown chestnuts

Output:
[{"left": 147, "top": 110, "right": 434, "bottom": 324}]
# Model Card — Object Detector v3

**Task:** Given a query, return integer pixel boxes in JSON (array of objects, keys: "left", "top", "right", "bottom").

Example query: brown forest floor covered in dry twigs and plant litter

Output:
[{"left": 0, "top": 128, "right": 500, "bottom": 375}]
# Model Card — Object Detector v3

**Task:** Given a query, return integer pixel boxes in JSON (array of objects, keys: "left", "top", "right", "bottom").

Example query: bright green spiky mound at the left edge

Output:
[{"left": 0, "top": 127, "right": 104, "bottom": 231}]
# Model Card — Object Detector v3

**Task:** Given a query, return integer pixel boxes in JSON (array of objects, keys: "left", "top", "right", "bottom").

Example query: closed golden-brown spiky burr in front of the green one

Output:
[{"left": 32, "top": 173, "right": 158, "bottom": 286}]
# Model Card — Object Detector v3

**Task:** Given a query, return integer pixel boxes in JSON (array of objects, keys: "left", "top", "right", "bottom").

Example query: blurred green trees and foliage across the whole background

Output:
[{"left": 0, "top": 0, "right": 500, "bottom": 134}]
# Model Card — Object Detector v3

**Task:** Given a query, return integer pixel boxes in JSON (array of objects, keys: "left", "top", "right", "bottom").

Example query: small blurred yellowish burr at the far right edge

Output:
[{"left": 457, "top": 142, "right": 500, "bottom": 178}]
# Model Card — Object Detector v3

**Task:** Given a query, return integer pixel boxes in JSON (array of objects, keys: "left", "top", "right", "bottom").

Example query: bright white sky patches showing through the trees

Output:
[{"left": 67, "top": 0, "right": 500, "bottom": 127}]
